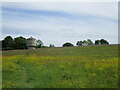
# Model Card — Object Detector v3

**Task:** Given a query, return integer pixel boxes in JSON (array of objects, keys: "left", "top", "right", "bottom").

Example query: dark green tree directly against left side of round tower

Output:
[{"left": 14, "top": 36, "right": 27, "bottom": 49}]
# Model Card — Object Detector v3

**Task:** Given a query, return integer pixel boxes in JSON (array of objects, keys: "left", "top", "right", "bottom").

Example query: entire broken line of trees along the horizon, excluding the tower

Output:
[{"left": 1, "top": 36, "right": 109, "bottom": 50}]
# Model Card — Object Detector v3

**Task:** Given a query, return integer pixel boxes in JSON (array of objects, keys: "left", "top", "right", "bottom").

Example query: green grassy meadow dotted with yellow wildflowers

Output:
[{"left": 2, "top": 45, "right": 118, "bottom": 88}]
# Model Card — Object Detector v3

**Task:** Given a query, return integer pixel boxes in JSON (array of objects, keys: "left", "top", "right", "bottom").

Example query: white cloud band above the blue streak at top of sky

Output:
[{"left": 3, "top": 2, "right": 118, "bottom": 19}]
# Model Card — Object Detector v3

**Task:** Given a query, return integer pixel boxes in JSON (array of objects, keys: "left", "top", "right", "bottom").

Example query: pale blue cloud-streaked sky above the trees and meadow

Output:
[{"left": 0, "top": 2, "right": 118, "bottom": 47}]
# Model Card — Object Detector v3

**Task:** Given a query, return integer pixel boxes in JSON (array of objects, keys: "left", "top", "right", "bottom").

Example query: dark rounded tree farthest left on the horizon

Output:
[{"left": 2, "top": 36, "right": 14, "bottom": 50}]
